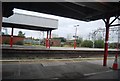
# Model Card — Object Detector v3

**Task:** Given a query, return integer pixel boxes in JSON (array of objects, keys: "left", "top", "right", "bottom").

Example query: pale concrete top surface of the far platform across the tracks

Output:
[{"left": 2, "top": 45, "right": 116, "bottom": 51}]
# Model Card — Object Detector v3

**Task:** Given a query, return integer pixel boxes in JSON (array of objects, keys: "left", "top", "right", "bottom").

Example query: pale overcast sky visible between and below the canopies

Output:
[{"left": 2, "top": 9, "right": 119, "bottom": 39}]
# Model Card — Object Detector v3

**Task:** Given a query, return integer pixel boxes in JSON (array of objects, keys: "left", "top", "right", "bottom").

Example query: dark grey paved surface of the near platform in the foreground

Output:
[{"left": 2, "top": 61, "right": 118, "bottom": 79}]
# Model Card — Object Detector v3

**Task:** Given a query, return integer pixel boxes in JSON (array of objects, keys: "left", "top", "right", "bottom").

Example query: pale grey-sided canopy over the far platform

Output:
[{"left": 2, "top": 13, "right": 58, "bottom": 31}]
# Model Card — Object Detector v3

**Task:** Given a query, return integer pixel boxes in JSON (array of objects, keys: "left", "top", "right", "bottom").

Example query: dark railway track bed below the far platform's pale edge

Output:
[{"left": 2, "top": 48, "right": 116, "bottom": 59}]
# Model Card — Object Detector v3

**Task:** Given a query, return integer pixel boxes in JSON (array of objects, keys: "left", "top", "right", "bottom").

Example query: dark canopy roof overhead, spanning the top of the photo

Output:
[{"left": 2, "top": 0, "right": 120, "bottom": 21}]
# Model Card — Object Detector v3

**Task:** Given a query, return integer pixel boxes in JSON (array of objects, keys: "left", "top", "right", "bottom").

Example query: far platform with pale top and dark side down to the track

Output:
[{"left": 2, "top": 45, "right": 117, "bottom": 59}]
